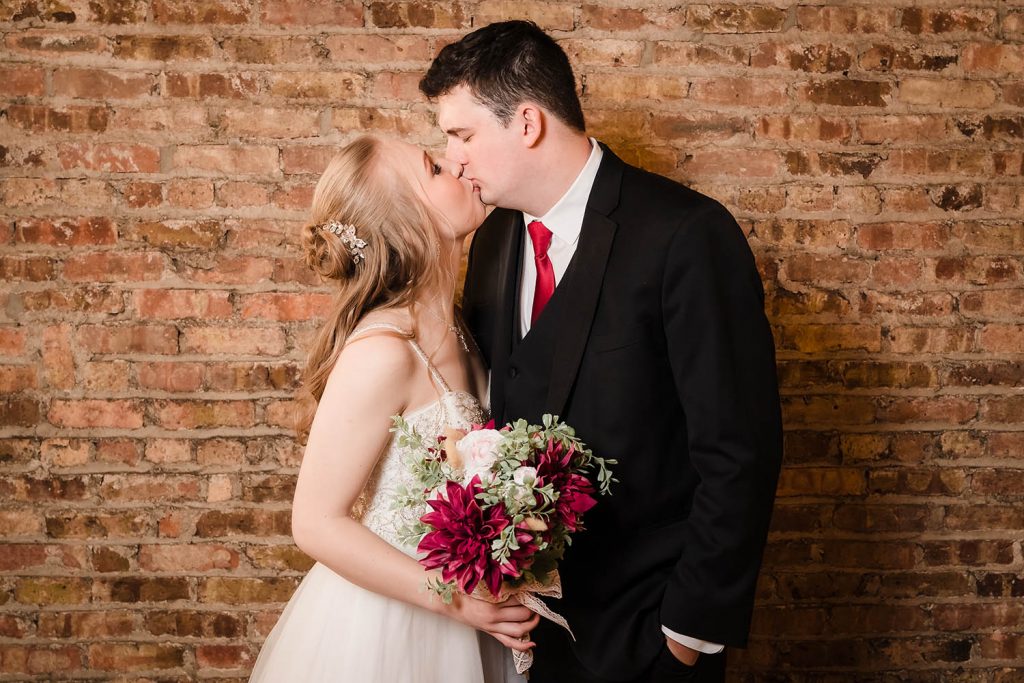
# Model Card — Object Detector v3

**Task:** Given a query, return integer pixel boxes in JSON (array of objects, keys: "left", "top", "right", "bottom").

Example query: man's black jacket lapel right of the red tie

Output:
[{"left": 544, "top": 144, "right": 625, "bottom": 415}]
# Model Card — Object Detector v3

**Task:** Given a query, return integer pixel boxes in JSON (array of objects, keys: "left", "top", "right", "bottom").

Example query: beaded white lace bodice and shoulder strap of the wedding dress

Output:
[{"left": 344, "top": 323, "right": 486, "bottom": 557}]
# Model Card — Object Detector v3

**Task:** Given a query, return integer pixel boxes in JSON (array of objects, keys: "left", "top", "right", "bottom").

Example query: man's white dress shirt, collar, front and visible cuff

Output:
[{"left": 519, "top": 137, "right": 725, "bottom": 654}]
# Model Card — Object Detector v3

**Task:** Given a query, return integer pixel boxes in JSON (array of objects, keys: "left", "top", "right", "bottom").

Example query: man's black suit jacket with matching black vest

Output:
[{"left": 463, "top": 147, "right": 782, "bottom": 679}]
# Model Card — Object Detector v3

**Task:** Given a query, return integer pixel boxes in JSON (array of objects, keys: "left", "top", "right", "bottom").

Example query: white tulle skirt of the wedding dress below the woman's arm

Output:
[{"left": 249, "top": 562, "right": 525, "bottom": 683}]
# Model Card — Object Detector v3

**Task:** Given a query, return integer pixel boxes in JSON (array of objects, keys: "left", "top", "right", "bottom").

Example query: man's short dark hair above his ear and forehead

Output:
[{"left": 420, "top": 20, "right": 586, "bottom": 132}]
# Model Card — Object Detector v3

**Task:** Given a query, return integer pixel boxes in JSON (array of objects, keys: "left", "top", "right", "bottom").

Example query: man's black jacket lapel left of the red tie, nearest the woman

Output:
[{"left": 490, "top": 209, "right": 523, "bottom": 421}]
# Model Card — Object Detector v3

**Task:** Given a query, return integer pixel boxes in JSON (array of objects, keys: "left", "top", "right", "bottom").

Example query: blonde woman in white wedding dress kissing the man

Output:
[{"left": 250, "top": 136, "right": 538, "bottom": 683}]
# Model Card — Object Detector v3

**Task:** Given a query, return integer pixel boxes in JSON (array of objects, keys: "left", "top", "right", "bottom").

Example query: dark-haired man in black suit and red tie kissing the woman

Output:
[{"left": 420, "top": 22, "right": 781, "bottom": 683}]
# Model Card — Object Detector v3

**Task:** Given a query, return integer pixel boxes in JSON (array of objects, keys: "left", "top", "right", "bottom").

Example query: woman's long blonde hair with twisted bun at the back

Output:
[{"left": 300, "top": 135, "right": 452, "bottom": 432}]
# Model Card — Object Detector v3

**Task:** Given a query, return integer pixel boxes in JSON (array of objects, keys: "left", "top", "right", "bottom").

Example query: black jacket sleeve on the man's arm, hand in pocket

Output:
[{"left": 660, "top": 201, "right": 781, "bottom": 646}]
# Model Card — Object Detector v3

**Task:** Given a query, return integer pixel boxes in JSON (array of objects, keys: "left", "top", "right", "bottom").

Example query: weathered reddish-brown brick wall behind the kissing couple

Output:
[{"left": 0, "top": 0, "right": 1024, "bottom": 683}]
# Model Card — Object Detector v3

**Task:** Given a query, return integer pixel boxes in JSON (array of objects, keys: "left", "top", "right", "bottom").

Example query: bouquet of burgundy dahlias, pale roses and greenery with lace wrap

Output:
[{"left": 392, "top": 415, "right": 616, "bottom": 673}]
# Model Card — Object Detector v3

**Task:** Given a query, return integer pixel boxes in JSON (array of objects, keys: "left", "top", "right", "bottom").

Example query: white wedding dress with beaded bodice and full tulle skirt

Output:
[{"left": 249, "top": 324, "right": 526, "bottom": 683}]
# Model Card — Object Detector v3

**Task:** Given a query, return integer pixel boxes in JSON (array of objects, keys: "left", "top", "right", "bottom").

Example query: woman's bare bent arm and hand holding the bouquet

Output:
[{"left": 292, "top": 335, "right": 537, "bottom": 649}]
